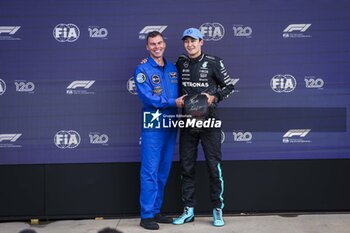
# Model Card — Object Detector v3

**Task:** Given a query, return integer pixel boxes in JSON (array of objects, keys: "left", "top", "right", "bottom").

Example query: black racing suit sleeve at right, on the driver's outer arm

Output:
[{"left": 214, "top": 59, "right": 234, "bottom": 101}]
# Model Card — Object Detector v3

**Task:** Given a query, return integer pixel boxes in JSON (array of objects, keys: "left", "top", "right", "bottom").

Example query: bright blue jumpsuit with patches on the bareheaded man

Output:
[{"left": 134, "top": 56, "right": 178, "bottom": 219}]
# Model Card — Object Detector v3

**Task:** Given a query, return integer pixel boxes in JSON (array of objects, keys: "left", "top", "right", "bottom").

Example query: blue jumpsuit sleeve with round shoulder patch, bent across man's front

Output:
[{"left": 134, "top": 67, "right": 176, "bottom": 108}]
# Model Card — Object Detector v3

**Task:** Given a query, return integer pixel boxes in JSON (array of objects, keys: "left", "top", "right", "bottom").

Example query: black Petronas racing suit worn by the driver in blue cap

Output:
[{"left": 176, "top": 53, "right": 234, "bottom": 208}]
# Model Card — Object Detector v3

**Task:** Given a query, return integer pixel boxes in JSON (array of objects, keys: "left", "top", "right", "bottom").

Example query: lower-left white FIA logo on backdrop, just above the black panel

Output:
[{"left": 54, "top": 130, "right": 80, "bottom": 149}]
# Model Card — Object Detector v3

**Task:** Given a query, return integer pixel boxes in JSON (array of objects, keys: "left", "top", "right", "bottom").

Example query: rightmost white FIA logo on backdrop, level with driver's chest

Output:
[{"left": 270, "top": 74, "right": 297, "bottom": 93}]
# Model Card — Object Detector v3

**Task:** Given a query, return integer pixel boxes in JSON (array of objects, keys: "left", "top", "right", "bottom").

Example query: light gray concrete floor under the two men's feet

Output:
[{"left": 0, "top": 213, "right": 350, "bottom": 233}]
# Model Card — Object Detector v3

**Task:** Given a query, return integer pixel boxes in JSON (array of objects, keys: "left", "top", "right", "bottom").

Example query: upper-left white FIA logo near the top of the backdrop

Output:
[{"left": 53, "top": 23, "right": 80, "bottom": 42}]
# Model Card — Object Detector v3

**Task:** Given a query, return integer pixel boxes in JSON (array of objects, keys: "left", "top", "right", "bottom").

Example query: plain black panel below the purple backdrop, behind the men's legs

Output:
[{"left": 0, "top": 160, "right": 350, "bottom": 219}]
